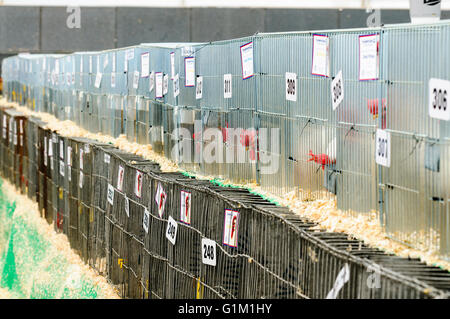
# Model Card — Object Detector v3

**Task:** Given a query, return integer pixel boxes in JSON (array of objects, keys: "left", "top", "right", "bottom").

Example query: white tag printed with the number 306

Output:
[{"left": 428, "top": 79, "right": 450, "bottom": 121}]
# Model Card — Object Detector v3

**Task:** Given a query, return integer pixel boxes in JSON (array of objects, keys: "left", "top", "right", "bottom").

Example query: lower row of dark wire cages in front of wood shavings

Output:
[{"left": 0, "top": 109, "right": 450, "bottom": 298}]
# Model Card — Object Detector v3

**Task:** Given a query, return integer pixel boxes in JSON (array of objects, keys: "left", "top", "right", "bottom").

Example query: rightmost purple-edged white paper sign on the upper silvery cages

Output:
[{"left": 359, "top": 34, "right": 379, "bottom": 81}]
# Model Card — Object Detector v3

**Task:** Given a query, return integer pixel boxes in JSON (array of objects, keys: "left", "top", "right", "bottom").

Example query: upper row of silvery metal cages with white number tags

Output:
[{"left": 2, "top": 21, "right": 450, "bottom": 258}]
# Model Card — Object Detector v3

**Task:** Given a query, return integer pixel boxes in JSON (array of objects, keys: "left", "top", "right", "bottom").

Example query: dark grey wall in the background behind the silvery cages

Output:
[{"left": 0, "top": 6, "right": 450, "bottom": 69}]
